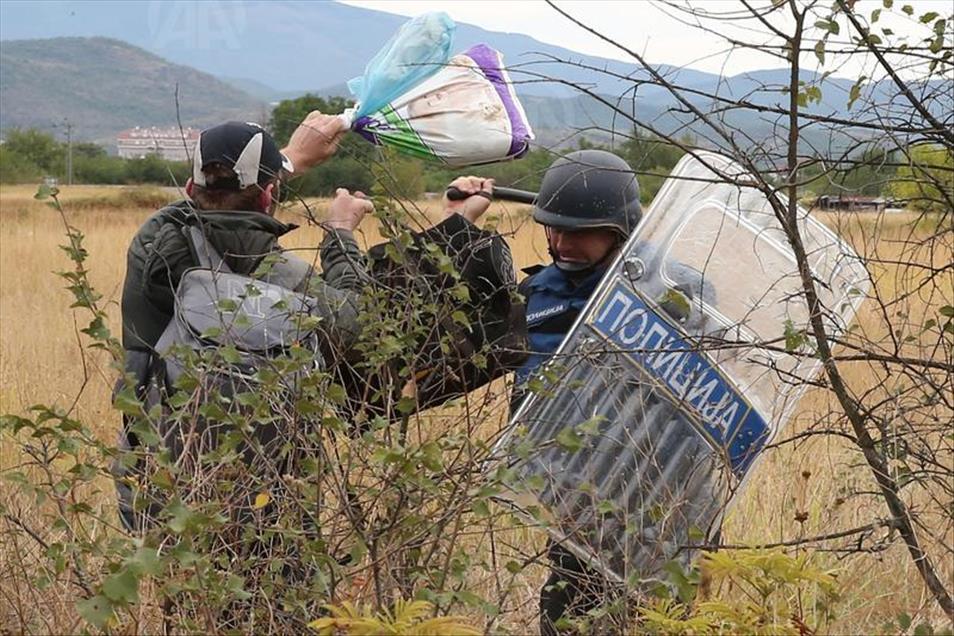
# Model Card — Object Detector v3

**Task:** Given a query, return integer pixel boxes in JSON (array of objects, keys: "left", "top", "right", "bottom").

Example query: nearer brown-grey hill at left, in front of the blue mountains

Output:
[{"left": 0, "top": 38, "right": 268, "bottom": 143}]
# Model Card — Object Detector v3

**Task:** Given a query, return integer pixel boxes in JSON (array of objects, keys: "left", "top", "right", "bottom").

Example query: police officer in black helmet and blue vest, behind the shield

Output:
[{"left": 451, "top": 150, "right": 642, "bottom": 635}]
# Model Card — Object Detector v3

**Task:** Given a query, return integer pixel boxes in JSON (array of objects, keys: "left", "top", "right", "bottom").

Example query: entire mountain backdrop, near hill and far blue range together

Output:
[{"left": 0, "top": 0, "right": 944, "bottom": 150}]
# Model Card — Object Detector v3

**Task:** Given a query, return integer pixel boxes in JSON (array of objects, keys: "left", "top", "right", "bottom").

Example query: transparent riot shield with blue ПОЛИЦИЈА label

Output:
[{"left": 496, "top": 153, "right": 869, "bottom": 582}]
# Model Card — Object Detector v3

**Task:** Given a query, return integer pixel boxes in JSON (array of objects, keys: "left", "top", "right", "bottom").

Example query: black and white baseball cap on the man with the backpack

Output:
[{"left": 192, "top": 121, "right": 294, "bottom": 190}]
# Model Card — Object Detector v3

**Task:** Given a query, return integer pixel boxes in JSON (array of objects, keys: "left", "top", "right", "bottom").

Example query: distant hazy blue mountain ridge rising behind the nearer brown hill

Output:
[{"left": 0, "top": 0, "right": 714, "bottom": 97}]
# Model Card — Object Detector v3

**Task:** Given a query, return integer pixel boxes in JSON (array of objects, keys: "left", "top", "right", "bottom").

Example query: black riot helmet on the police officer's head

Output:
[{"left": 533, "top": 150, "right": 643, "bottom": 239}]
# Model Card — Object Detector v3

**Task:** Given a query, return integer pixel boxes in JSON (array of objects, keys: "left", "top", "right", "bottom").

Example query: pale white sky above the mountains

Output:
[{"left": 344, "top": 0, "right": 951, "bottom": 76}]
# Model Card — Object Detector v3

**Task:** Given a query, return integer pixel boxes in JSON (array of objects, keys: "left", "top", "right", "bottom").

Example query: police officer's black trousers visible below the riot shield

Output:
[{"left": 540, "top": 541, "right": 620, "bottom": 636}]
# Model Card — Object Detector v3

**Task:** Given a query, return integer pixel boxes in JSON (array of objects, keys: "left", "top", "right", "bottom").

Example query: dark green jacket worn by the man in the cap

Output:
[{"left": 113, "top": 201, "right": 367, "bottom": 530}]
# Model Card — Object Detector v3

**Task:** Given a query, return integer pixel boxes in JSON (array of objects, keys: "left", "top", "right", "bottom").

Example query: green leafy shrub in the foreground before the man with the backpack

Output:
[{"left": 0, "top": 186, "right": 510, "bottom": 633}]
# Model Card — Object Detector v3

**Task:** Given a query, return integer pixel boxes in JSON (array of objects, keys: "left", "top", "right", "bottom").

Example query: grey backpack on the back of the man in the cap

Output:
[{"left": 113, "top": 225, "right": 325, "bottom": 529}]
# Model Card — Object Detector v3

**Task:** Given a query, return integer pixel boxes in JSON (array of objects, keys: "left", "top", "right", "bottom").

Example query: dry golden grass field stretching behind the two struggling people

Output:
[{"left": 0, "top": 186, "right": 954, "bottom": 634}]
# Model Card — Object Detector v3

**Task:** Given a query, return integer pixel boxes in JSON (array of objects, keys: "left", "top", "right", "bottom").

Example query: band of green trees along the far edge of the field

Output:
[{"left": 0, "top": 94, "right": 954, "bottom": 210}]
